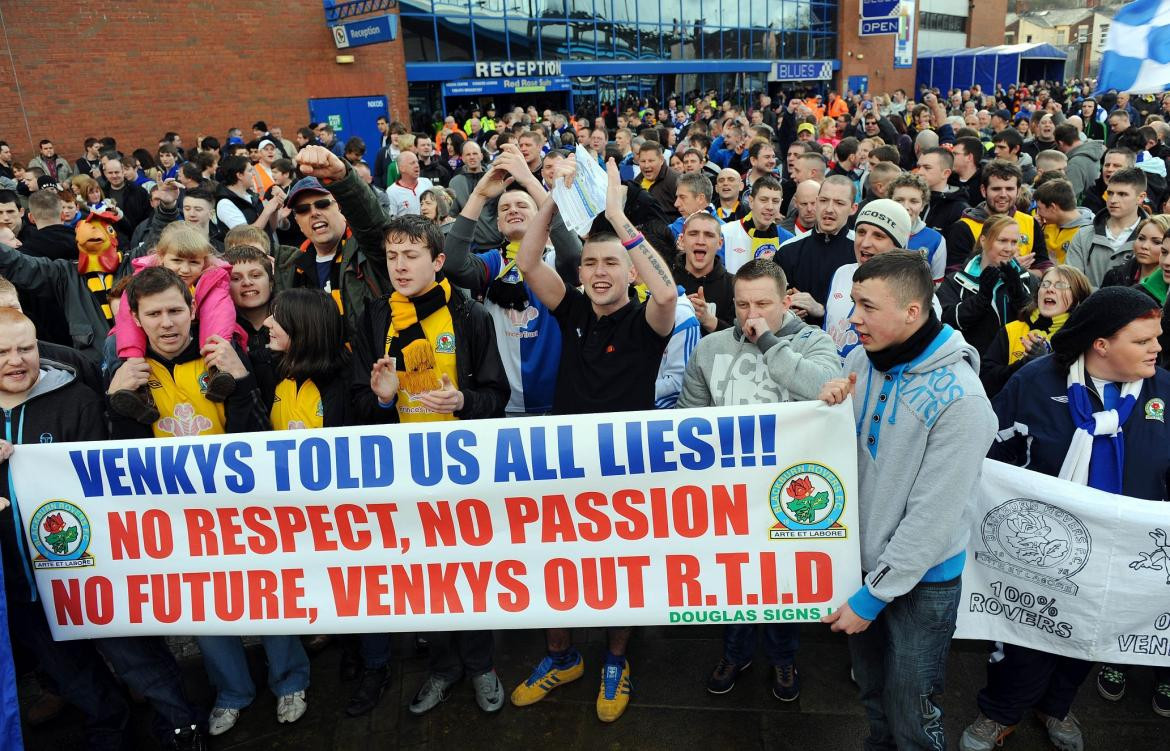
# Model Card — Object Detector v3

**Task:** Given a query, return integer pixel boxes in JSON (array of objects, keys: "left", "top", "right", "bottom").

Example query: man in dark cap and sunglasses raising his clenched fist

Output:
[{"left": 274, "top": 146, "right": 390, "bottom": 336}]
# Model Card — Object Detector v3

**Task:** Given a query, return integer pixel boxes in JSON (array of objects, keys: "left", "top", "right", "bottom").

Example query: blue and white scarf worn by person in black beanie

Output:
[{"left": 1059, "top": 356, "right": 1142, "bottom": 492}]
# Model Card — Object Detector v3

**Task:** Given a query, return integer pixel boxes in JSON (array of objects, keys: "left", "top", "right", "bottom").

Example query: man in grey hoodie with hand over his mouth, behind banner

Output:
[{"left": 677, "top": 259, "right": 840, "bottom": 702}]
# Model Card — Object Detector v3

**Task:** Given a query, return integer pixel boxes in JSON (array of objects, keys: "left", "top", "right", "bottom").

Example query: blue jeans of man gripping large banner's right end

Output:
[{"left": 849, "top": 578, "right": 962, "bottom": 751}]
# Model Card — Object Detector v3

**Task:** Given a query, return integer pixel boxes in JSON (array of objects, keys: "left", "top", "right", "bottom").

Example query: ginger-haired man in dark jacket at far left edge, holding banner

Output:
[{"left": 0, "top": 306, "right": 206, "bottom": 751}]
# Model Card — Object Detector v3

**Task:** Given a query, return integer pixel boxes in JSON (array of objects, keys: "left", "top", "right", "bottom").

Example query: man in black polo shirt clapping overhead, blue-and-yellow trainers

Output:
[{"left": 511, "top": 159, "right": 679, "bottom": 722}]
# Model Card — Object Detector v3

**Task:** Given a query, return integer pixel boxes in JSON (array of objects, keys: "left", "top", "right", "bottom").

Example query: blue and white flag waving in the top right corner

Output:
[{"left": 1097, "top": 0, "right": 1170, "bottom": 94}]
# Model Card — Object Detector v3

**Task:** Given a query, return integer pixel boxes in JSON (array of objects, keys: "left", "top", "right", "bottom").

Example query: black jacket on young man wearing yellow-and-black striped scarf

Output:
[{"left": 350, "top": 290, "right": 511, "bottom": 423}]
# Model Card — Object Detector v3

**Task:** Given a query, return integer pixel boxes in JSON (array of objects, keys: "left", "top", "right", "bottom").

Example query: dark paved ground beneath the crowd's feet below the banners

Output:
[{"left": 18, "top": 626, "right": 1170, "bottom": 751}]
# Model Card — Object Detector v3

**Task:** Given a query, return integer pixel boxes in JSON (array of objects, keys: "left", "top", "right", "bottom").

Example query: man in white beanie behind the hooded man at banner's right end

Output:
[{"left": 811, "top": 198, "right": 910, "bottom": 361}]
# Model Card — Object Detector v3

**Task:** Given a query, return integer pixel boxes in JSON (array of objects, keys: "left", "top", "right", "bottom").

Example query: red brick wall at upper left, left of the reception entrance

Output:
[{"left": 0, "top": 0, "right": 408, "bottom": 161}]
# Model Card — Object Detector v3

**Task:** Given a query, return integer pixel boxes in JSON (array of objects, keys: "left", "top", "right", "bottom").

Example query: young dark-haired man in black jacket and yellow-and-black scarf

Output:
[{"left": 346, "top": 200, "right": 509, "bottom": 717}]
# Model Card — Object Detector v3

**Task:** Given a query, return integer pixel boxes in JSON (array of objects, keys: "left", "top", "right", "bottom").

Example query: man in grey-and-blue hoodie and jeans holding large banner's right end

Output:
[{"left": 820, "top": 250, "right": 997, "bottom": 751}]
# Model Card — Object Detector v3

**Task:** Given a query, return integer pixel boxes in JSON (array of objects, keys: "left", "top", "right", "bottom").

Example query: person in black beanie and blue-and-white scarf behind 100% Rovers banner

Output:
[{"left": 959, "top": 287, "right": 1170, "bottom": 751}]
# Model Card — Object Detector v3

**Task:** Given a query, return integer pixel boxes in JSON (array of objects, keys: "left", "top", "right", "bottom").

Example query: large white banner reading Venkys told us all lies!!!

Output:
[{"left": 11, "top": 402, "right": 860, "bottom": 639}]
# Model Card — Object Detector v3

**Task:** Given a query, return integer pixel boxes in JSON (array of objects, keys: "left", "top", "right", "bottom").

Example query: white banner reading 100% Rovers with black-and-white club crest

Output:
[{"left": 955, "top": 460, "right": 1170, "bottom": 666}]
